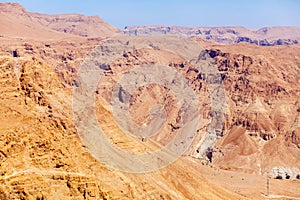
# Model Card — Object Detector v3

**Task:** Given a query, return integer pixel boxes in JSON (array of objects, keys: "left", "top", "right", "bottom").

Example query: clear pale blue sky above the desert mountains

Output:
[{"left": 2, "top": 0, "right": 300, "bottom": 29}]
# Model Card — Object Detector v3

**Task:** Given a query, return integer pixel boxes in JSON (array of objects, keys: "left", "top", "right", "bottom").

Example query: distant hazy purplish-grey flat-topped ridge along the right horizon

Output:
[{"left": 123, "top": 25, "right": 300, "bottom": 46}]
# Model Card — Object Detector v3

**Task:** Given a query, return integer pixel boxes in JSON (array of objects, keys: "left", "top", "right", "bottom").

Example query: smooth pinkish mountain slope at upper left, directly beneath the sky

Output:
[{"left": 0, "top": 3, "right": 121, "bottom": 39}]
